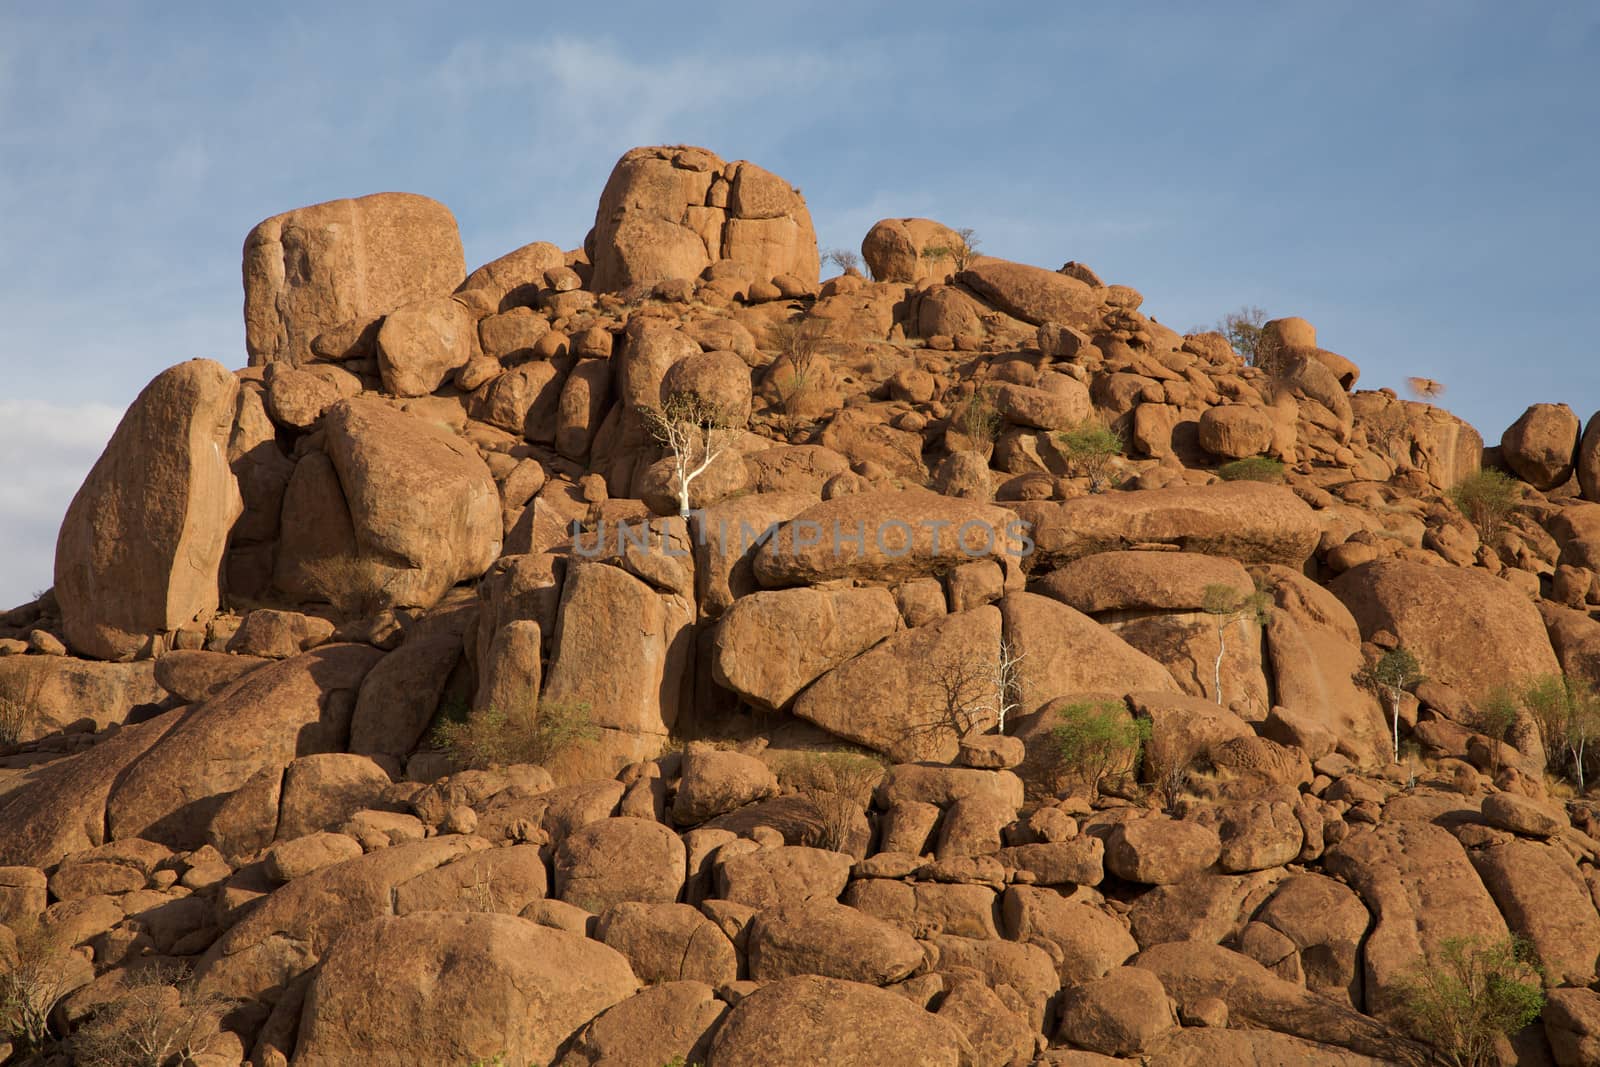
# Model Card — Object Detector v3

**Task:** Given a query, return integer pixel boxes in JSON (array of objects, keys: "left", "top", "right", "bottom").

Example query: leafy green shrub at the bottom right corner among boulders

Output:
[{"left": 1403, "top": 937, "right": 1544, "bottom": 1067}]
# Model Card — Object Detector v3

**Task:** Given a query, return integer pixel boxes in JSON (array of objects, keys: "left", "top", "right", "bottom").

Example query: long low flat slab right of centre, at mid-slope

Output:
[{"left": 1014, "top": 482, "right": 1322, "bottom": 568}]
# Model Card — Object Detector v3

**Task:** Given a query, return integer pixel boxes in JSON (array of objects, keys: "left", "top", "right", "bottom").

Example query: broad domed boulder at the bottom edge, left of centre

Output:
[{"left": 294, "top": 912, "right": 638, "bottom": 1067}]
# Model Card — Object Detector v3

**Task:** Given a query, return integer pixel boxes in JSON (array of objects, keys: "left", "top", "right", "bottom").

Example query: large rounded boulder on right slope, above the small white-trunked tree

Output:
[{"left": 1330, "top": 560, "right": 1560, "bottom": 696}]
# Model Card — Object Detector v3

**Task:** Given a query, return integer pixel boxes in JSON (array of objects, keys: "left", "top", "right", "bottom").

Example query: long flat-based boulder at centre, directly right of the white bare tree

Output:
[{"left": 755, "top": 490, "right": 1024, "bottom": 589}]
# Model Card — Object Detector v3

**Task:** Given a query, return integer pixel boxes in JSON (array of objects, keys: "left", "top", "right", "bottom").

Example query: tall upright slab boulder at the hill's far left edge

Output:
[{"left": 56, "top": 360, "right": 243, "bottom": 659}]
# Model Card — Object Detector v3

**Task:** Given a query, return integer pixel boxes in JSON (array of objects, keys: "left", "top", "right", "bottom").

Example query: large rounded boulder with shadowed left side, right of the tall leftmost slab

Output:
[{"left": 278, "top": 398, "right": 504, "bottom": 613}]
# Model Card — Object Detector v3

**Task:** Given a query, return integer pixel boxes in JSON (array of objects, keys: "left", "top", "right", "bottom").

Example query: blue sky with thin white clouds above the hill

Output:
[{"left": 0, "top": 0, "right": 1600, "bottom": 606}]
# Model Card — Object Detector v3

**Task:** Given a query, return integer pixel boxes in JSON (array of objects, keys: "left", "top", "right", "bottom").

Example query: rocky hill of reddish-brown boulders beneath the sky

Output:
[{"left": 0, "top": 147, "right": 1600, "bottom": 1067}]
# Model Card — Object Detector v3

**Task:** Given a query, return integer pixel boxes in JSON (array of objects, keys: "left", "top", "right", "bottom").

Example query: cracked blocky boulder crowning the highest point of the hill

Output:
[{"left": 592, "top": 146, "right": 821, "bottom": 293}]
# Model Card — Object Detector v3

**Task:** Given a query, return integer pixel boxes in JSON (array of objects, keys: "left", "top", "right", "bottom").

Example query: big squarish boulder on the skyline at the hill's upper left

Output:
[{"left": 245, "top": 192, "right": 466, "bottom": 366}]
